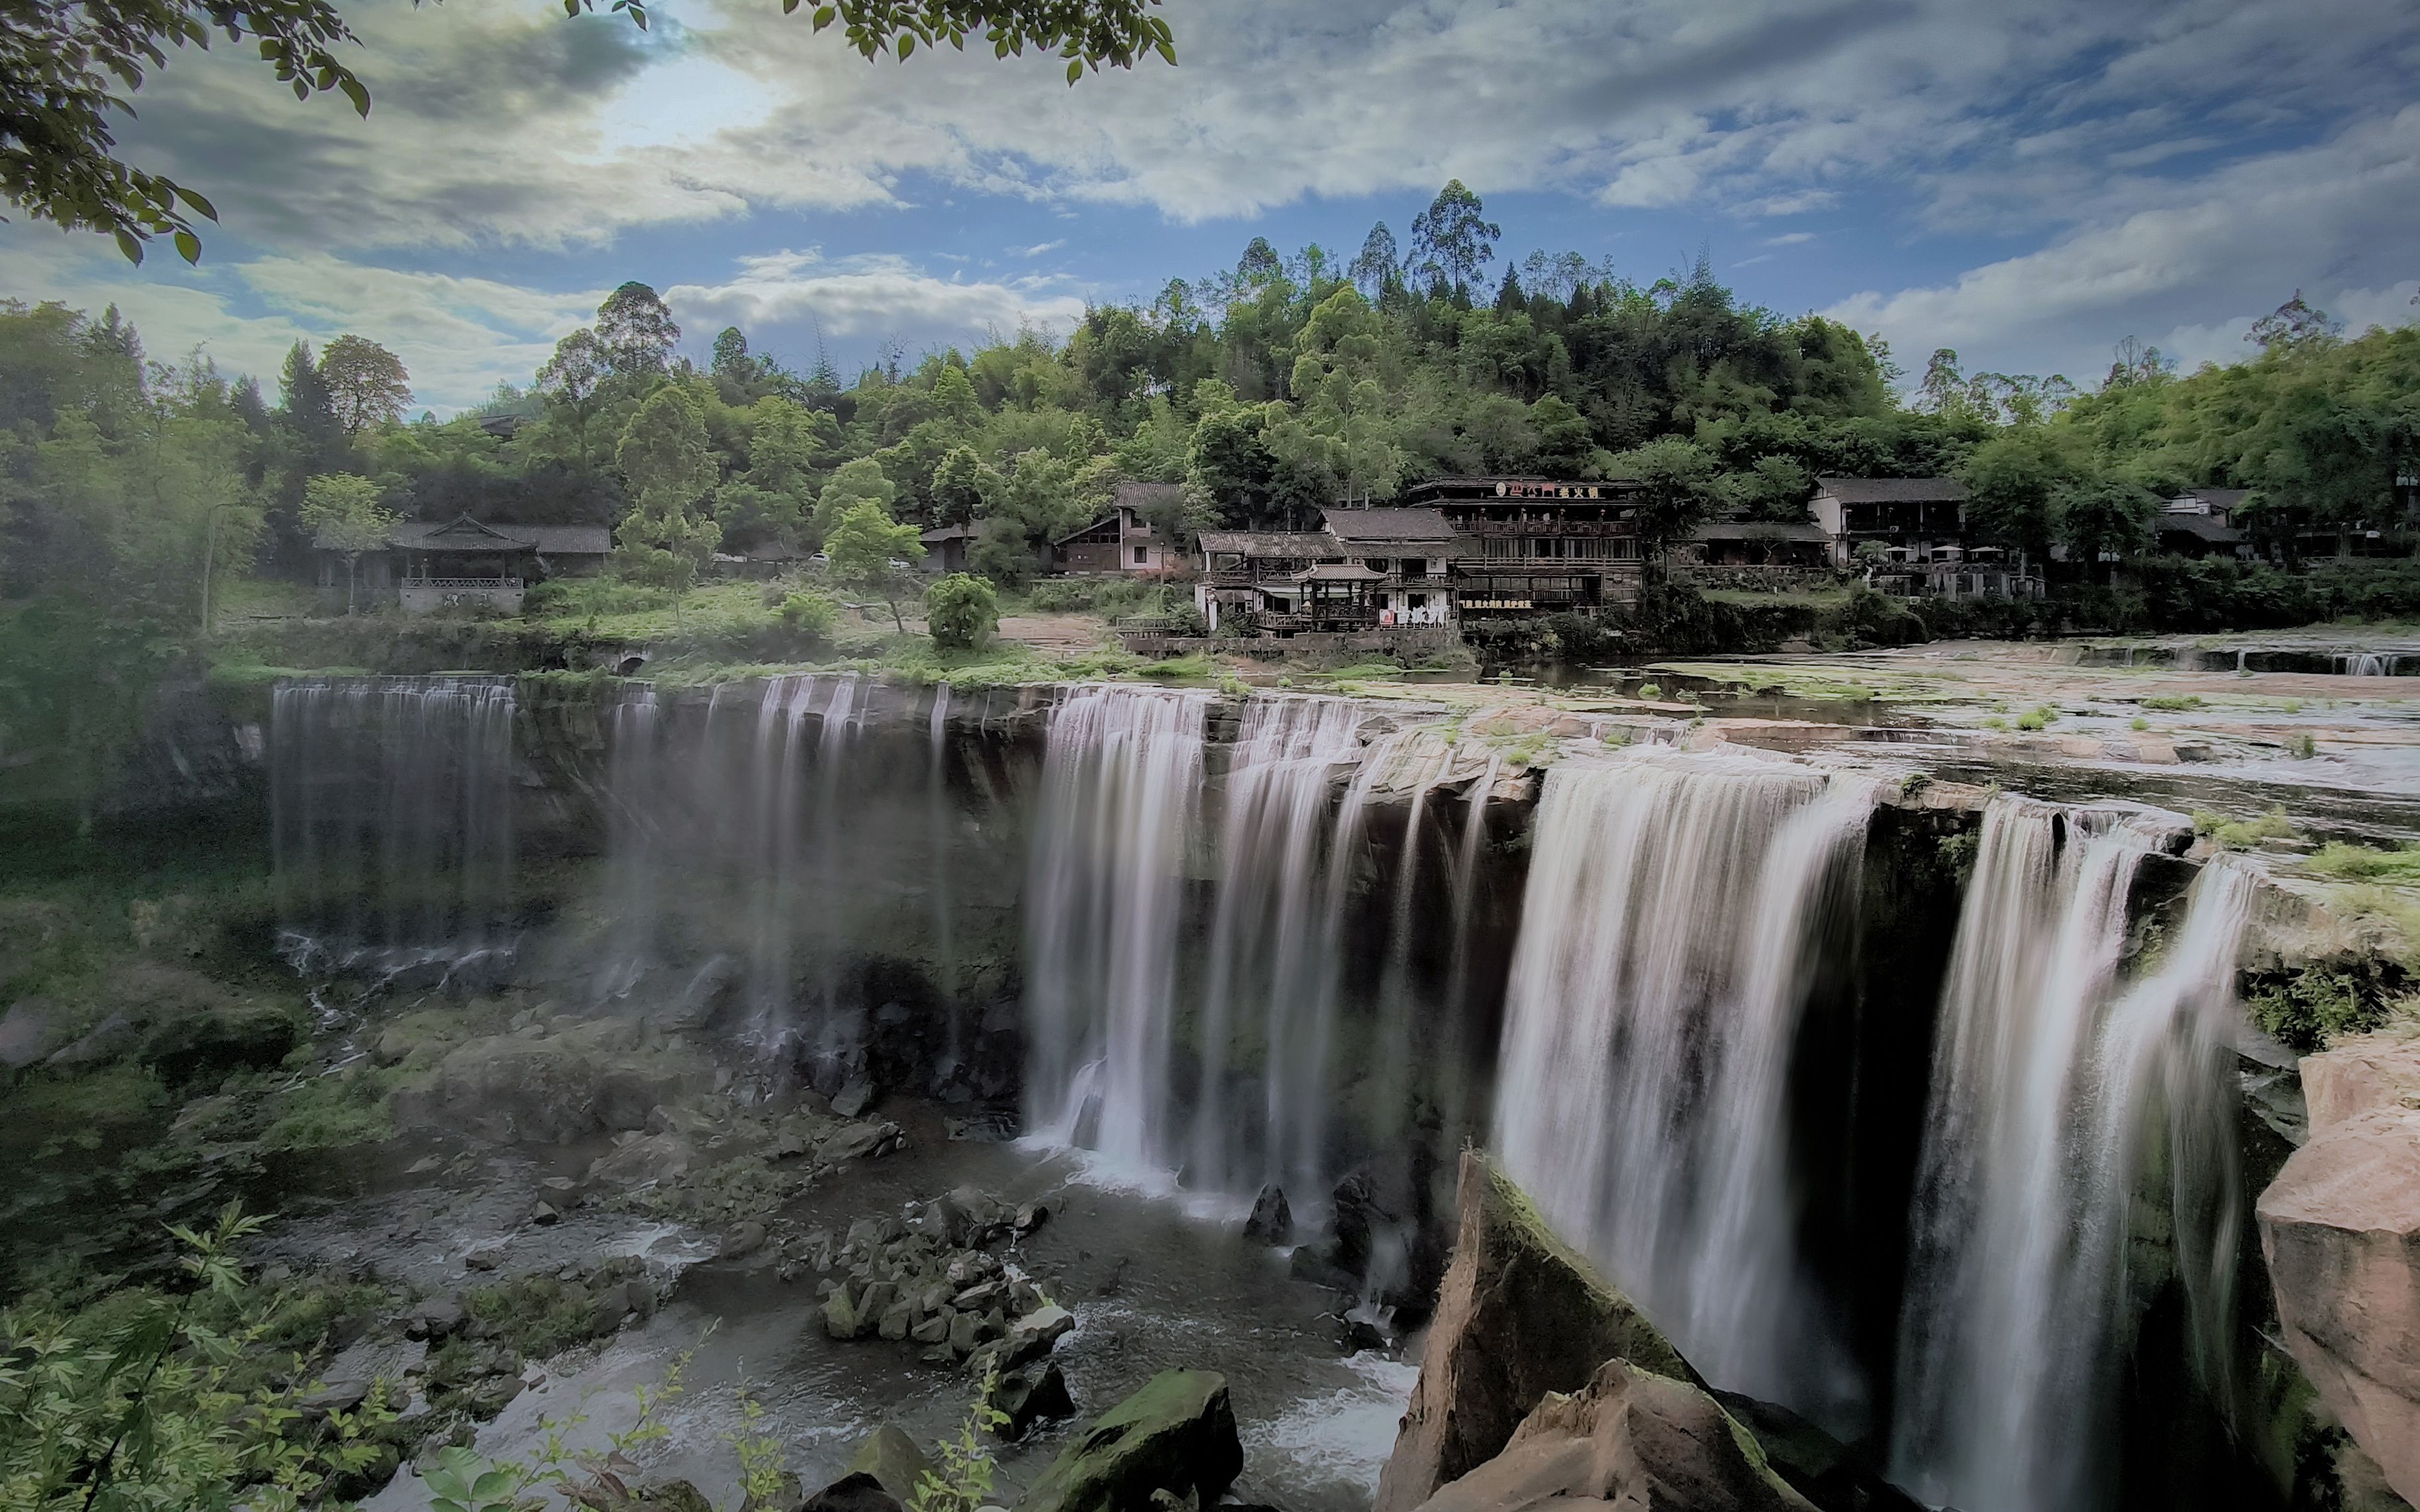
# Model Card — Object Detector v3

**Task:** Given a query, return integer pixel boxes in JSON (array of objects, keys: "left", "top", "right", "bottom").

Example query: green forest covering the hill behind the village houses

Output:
[{"left": 0, "top": 184, "right": 2420, "bottom": 798}]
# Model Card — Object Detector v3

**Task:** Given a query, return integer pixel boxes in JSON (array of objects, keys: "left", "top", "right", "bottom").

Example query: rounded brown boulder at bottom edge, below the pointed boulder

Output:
[{"left": 1420, "top": 1359, "right": 1815, "bottom": 1512}]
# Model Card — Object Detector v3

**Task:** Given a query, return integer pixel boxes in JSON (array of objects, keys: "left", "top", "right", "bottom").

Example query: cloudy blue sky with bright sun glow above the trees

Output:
[{"left": 0, "top": 0, "right": 2420, "bottom": 416}]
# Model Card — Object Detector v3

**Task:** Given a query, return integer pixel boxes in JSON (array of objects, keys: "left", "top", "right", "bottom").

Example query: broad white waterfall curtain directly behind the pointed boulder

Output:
[{"left": 1495, "top": 753, "right": 1876, "bottom": 1420}]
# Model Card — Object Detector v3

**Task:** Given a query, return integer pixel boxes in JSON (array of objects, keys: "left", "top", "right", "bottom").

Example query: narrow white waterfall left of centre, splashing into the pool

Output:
[{"left": 1026, "top": 687, "right": 1210, "bottom": 1171}]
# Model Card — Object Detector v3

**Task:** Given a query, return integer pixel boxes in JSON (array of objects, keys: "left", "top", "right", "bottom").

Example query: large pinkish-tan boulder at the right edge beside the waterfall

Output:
[{"left": 2258, "top": 1033, "right": 2420, "bottom": 1502}]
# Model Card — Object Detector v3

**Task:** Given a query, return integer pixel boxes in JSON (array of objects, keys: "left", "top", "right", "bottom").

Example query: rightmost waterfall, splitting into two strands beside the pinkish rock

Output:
[{"left": 1892, "top": 798, "right": 2248, "bottom": 1512}]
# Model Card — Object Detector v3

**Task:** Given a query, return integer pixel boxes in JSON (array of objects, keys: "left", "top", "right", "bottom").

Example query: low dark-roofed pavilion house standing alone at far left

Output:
[{"left": 312, "top": 513, "right": 612, "bottom": 615}]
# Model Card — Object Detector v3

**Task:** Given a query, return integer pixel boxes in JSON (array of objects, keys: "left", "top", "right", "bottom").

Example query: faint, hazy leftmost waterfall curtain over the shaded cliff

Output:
[{"left": 269, "top": 678, "right": 513, "bottom": 970}]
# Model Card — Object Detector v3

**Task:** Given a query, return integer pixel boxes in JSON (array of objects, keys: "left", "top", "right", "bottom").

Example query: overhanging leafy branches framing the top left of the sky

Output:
[{"left": 0, "top": 0, "right": 1176, "bottom": 262}]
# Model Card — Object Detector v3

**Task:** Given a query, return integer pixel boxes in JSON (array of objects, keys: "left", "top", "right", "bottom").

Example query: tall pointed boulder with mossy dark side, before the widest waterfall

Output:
[{"left": 1372, "top": 1152, "right": 1704, "bottom": 1512}]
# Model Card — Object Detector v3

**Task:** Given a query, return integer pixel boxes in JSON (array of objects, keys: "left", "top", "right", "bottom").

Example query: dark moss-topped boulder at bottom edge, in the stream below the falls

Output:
[{"left": 1016, "top": 1369, "right": 1244, "bottom": 1512}]
